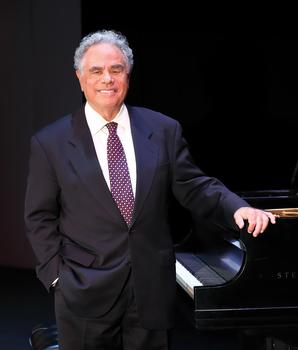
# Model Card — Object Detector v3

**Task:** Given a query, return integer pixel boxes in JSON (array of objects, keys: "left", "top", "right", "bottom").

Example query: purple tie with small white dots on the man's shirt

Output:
[{"left": 106, "top": 122, "right": 134, "bottom": 225}]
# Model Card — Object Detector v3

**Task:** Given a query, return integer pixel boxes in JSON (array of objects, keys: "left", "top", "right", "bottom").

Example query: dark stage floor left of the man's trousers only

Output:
[{"left": 0, "top": 267, "right": 54, "bottom": 350}]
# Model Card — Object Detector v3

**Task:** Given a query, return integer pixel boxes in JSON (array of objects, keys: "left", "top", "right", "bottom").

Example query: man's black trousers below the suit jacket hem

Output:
[{"left": 55, "top": 270, "right": 168, "bottom": 350}]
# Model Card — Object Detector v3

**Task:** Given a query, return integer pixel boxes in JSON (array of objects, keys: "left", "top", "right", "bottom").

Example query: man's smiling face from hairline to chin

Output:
[{"left": 76, "top": 43, "right": 129, "bottom": 120}]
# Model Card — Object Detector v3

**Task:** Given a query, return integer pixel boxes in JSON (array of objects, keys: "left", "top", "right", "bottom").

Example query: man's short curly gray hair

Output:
[{"left": 74, "top": 30, "right": 133, "bottom": 72}]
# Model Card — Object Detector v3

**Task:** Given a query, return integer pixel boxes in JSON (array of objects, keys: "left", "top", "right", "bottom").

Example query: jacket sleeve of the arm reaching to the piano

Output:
[{"left": 171, "top": 123, "right": 249, "bottom": 229}]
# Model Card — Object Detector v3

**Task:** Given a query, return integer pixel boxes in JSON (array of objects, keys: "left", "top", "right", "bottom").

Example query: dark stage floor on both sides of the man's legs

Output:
[{"left": 0, "top": 267, "right": 294, "bottom": 350}]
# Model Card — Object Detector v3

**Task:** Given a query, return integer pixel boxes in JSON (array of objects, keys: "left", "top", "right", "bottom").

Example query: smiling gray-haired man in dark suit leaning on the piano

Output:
[{"left": 25, "top": 31, "right": 275, "bottom": 350}]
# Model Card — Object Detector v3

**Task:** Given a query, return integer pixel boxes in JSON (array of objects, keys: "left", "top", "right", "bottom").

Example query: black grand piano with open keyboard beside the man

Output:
[{"left": 176, "top": 163, "right": 298, "bottom": 350}]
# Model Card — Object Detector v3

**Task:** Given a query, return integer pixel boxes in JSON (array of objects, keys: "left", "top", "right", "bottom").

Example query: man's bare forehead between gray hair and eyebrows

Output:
[{"left": 82, "top": 43, "right": 126, "bottom": 67}]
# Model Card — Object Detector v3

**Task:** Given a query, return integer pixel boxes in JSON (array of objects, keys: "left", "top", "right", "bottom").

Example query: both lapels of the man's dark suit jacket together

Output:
[{"left": 68, "top": 107, "right": 158, "bottom": 223}]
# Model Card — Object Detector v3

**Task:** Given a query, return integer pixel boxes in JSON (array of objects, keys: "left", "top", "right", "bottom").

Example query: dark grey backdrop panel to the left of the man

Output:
[{"left": 0, "top": 0, "right": 81, "bottom": 268}]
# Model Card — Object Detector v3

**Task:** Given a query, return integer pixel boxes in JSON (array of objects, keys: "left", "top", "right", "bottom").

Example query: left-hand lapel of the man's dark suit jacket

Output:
[{"left": 68, "top": 109, "right": 122, "bottom": 217}]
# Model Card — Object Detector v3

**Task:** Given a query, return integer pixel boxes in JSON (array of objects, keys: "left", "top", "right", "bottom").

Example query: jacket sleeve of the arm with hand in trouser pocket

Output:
[{"left": 24, "top": 136, "right": 61, "bottom": 290}]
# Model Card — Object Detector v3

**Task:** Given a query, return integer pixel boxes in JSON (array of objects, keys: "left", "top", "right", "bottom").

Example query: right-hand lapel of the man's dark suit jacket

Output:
[{"left": 128, "top": 107, "right": 158, "bottom": 223}]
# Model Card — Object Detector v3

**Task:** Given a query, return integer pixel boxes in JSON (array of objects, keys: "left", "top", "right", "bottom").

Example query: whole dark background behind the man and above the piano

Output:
[{"left": 0, "top": 0, "right": 298, "bottom": 268}]
